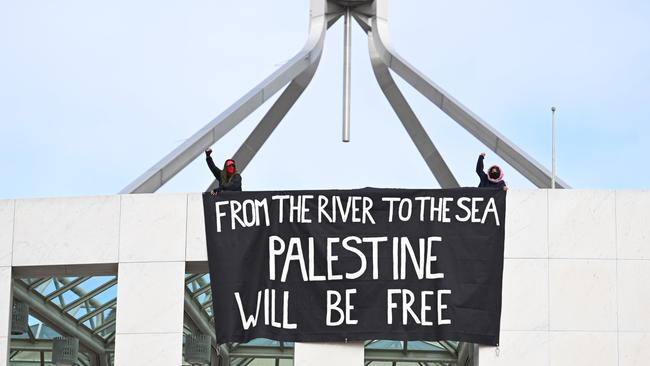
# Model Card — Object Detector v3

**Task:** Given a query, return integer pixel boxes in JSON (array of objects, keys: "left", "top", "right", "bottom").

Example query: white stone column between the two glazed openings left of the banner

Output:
[{"left": 115, "top": 194, "right": 187, "bottom": 366}]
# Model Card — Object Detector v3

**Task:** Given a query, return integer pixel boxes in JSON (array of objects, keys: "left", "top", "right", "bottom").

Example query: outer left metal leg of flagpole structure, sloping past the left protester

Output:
[{"left": 120, "top": 0, "right": 339, "bottom": 193}]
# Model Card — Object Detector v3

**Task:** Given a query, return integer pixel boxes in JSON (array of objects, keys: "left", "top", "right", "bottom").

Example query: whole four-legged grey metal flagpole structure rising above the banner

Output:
[{"left": 120, "top": 0, "right": 569, "bottom": 193}]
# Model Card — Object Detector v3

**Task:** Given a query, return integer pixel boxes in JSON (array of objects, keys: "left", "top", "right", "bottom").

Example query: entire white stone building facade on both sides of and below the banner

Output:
[{"left": 0, "top": 189, "right": 650, "bottom": 366}]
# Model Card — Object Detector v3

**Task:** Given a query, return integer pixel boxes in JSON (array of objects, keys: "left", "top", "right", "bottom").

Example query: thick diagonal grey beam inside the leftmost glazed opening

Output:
[{"left": 13, "top": 280, "right": 106, "bottom": 355}]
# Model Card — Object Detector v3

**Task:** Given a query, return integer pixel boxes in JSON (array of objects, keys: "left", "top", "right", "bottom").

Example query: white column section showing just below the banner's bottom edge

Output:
[{"left": 293, "top": 342, "right": 364, "bottom": 366}]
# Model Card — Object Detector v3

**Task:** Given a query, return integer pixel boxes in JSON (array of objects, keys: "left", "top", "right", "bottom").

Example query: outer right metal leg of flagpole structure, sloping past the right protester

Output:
[{"left": 371, "top": 0, "right": 569, "bottom": 188}]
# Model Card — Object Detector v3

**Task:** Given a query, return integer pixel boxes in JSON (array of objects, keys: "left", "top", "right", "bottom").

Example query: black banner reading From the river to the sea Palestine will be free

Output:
[{"left": 203, "top": 188, "right": 506, "bottom": 345}]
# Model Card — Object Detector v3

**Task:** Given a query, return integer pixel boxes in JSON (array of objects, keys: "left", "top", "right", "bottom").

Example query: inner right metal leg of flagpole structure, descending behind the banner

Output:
[{"left": 368, "top": 31, "right": 460, "bottom": 188}]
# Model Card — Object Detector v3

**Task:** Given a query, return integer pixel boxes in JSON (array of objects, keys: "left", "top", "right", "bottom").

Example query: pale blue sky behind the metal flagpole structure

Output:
[{"left": 0, "top": 0, "right": 650, "bottom": 198}]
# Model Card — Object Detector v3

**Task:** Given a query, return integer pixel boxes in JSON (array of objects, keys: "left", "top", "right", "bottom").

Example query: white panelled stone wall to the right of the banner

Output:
[{"left": 479, "top": 190, "right": 650, "bottom": 366}]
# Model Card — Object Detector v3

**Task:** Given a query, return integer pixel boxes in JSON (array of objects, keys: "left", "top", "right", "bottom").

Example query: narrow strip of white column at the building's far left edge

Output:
[{"left": 0, "top": 201, "right": 14, "bottom": 366}]
